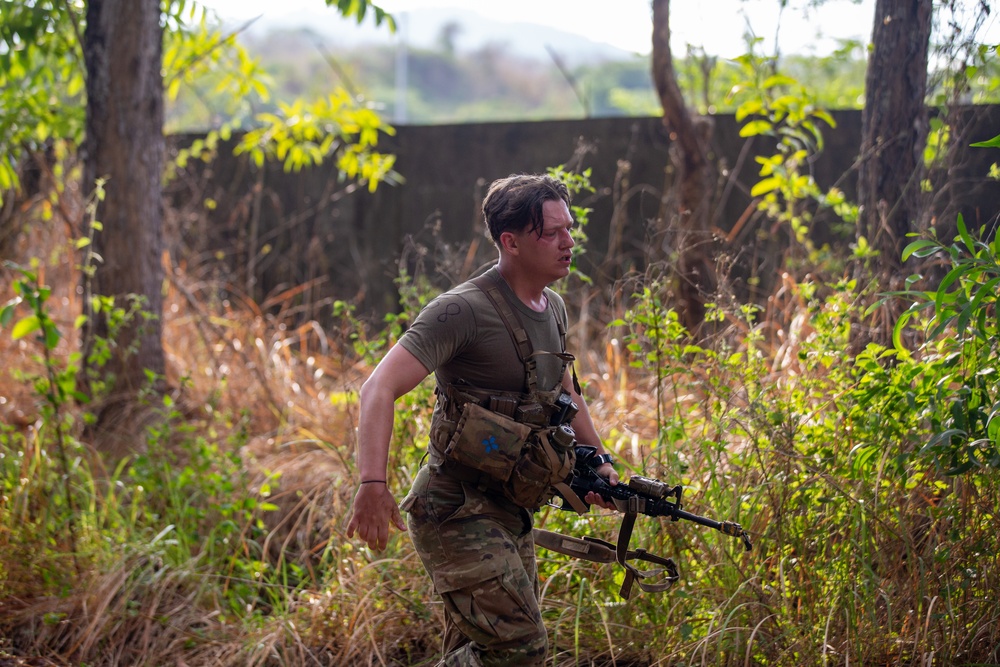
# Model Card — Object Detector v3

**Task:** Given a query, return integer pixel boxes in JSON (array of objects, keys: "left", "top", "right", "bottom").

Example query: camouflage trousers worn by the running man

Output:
[{"left": 402, "top": 465, "right": 548, "bottom": 667}]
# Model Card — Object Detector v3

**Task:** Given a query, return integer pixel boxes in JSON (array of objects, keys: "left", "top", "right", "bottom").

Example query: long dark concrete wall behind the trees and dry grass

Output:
[{"left": 170, "top": 107, "right": 1000, "bottom": 317}]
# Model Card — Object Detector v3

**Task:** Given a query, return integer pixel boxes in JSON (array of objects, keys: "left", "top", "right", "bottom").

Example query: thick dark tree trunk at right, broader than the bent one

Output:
[{"left": 858, "top": 0, "right": 932, "bottom": 274}]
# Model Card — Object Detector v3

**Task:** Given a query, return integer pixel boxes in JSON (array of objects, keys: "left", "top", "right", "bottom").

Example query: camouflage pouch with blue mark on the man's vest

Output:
[{"left": 444, "top": 403, "right": 531, "bottom": 482}]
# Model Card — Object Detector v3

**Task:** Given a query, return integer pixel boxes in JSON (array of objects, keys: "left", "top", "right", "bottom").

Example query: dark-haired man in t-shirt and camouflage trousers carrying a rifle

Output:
[{"left": 347, "top": 174, "right": 618, "bottom": 666}]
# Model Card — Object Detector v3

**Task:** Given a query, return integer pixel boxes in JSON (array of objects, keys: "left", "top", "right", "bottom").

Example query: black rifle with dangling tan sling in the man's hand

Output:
[{"left": 534, "top": 445, "right": 753, "bottom": 600}]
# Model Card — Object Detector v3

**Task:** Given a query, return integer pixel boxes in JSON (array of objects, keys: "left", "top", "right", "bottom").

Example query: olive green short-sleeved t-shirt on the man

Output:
[{"left": 399, "top": 266, "right": 567, "bottom": 392}]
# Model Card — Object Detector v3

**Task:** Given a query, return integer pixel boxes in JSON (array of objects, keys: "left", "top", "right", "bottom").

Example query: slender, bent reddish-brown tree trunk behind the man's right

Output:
[{"left": 652, "top": 0, "right": 717, "bottom": 333}]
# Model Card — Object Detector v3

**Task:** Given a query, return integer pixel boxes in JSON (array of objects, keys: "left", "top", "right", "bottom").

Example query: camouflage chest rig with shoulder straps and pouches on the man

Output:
[{"left": 431, "top": 274, "right": 587, "bottom": 512}]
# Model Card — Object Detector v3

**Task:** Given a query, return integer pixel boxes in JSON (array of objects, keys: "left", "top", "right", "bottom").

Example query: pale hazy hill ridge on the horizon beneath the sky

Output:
[{"left": 227, "top": 5, "right": 632, "bottom": 66}]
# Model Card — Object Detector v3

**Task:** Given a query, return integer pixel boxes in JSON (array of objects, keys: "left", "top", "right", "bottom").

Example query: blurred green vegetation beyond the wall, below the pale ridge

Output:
[{"left": 182, "top": 21, "right": 867, "bottom": 130}]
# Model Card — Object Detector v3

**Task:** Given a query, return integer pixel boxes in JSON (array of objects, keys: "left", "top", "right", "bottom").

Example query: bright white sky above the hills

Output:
[{"left": 193, "top": 0, "right": 875, "bottom": 57}]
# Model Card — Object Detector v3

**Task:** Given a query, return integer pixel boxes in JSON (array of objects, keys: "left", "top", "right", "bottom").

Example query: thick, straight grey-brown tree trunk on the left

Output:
[{"left": 83, "top": 0, "right": 164, "bottom": 412}]
